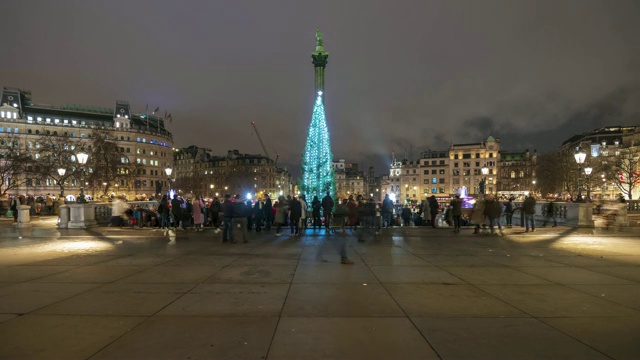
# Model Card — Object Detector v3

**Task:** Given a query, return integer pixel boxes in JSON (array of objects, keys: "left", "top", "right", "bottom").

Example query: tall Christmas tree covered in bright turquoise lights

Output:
[{"left": 302, "top": 91, "right": 336, "bottom": 203}]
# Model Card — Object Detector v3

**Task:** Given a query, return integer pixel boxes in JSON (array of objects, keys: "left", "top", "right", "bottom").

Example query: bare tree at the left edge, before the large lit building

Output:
[{"left": 0, "top": 133, "right": 33, "bottom": 196}]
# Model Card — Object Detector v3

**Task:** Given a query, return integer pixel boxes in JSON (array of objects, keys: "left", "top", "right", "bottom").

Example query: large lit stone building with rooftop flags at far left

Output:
[{"left": 0, "top": 87, "right": 173, "bottom": 198}]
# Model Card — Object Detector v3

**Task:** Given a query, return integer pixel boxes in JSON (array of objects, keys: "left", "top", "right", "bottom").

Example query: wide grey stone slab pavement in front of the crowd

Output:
[{"left": 0, "top": 218, "right": 640, "bottom": 359}]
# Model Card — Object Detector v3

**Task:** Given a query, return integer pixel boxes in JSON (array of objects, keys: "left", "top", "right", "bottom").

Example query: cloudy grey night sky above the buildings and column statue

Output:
[{"left": 0, "top": 0, "right": 640, "bottom": 175}]
